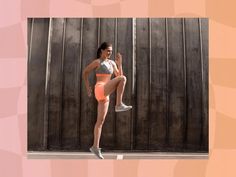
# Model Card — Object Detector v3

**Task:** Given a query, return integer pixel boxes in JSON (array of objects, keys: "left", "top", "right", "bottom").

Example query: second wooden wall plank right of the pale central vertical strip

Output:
[{"left": 149, "top": 18, "right": 167, "bottom": 150}]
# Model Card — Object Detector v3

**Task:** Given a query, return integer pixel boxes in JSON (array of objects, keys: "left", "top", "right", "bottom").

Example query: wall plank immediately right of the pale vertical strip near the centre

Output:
[{"left": 135, "top": 18, "right": 150, "bottom": 150}]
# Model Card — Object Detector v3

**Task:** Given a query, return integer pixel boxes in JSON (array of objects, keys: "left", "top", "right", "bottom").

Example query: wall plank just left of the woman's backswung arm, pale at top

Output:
[{"left": 61, "top": 18, "right": 82, "bottom": 149}]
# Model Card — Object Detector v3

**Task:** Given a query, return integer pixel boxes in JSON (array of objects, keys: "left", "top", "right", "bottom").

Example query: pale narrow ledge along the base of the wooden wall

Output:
[{"left": 27, "top": 151, "right": 208, "bottom": 160}]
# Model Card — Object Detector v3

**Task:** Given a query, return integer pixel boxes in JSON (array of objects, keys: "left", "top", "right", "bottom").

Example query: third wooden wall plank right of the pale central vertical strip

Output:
[{"left": 168, "top": 19, "right": 185, "bottom": 149}]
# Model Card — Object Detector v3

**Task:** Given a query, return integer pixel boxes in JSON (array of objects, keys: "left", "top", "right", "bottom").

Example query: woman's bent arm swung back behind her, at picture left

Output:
[{"left": 83, "top": 60, "right": 99, "bottom": 97}]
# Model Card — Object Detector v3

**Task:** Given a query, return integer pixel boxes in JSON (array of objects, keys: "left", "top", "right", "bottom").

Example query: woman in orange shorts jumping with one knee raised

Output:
[{"left": 83, "top": 42, "right": 132, "bottom": 159}]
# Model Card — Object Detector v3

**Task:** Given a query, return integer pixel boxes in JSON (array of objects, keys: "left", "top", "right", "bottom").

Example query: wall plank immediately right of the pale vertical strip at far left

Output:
[{"left": 48, "top": 19, "right": 65, "bottom": 149}]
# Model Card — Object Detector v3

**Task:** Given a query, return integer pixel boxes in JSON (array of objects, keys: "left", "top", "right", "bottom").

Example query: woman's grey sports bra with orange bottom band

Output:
[{"left": 95, "top": 59, "right": 114, "bottom": 76}]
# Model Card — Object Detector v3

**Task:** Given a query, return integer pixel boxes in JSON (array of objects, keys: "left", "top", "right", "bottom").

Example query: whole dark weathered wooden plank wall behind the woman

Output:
[{"left": 27, "top": 18, "right": 209, "bottom": 152}]
